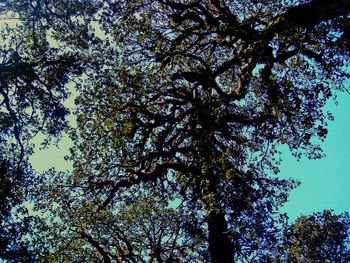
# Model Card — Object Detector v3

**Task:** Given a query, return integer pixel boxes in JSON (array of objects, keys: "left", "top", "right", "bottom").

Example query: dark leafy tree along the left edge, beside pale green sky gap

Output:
[{"left": 0, "top": 1, "right": 87, "bottom": 262}]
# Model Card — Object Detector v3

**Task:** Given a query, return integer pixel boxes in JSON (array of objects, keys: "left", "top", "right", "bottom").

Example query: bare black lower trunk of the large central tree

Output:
[{"left": 207, "top": 211, "right": 235, "bottom": 263}]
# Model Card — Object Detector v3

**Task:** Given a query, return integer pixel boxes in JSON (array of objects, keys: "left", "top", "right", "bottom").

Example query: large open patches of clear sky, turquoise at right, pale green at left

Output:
[{"left": 31, "top": 93, "right": 350, "bottom": 223}]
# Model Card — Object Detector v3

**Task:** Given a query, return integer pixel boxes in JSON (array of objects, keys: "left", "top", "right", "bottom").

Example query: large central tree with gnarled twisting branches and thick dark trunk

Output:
[{"left": 1, "top": 0, "right": 350, "bottom": 263}]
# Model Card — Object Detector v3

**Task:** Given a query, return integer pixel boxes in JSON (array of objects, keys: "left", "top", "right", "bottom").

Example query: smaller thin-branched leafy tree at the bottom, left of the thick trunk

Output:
[{"left": 32, "top": 171, "right": 206, "bottom": 263}]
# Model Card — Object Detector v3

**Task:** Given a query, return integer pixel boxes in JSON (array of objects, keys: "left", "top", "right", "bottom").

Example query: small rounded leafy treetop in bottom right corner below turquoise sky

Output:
[{"left": 286, "top": 210, "right": 350, "bottom": 262}]
